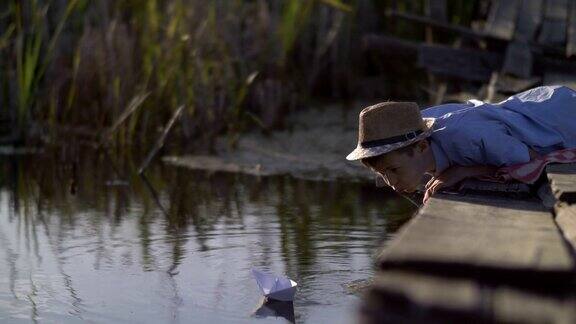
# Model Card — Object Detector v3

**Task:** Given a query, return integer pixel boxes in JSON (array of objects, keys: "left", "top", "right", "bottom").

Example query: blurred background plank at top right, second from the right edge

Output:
[{"left": 538, "top": 0, "right": 568, "bottom": 47}]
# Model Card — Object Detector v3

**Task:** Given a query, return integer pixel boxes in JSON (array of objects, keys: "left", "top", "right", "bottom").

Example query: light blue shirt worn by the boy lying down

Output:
[{"left": 422, "top": 86, "right": 576, "bottom": 174}]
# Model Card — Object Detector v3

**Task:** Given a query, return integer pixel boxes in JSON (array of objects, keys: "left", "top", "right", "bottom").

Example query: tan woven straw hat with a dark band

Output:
[{"left": 346, "top": 102, "right": 434, "bottom": 161}]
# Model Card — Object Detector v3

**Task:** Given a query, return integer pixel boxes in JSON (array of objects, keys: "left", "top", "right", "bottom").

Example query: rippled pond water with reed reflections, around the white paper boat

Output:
[{"left": 0, "top": 151, "right": 413, "bottom": 323}]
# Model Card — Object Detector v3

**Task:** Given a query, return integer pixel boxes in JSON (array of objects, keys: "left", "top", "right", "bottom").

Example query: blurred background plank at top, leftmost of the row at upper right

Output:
[{"left": 486, "top": 0, "right": 519, "bottom": 40}]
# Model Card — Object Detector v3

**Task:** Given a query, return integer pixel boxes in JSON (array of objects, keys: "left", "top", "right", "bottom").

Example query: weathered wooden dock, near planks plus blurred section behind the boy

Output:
[{"left": 361, "top": 0, "right": 576, "bottom": 323}]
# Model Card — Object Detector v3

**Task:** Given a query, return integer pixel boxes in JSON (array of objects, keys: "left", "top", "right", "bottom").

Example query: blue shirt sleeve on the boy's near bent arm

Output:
[{"left": 448, "top": 123, "right": 530, "bottom": 167}]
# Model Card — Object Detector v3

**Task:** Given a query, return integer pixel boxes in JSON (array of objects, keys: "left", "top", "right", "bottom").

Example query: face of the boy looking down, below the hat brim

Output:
[{"left": 372, "top": 144, "right": 429, "bottom": 192}]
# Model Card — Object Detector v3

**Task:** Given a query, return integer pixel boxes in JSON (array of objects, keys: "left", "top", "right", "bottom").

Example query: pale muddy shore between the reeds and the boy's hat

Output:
[{"left": 163, "top": 105, "right": 374, "bottom": 182}]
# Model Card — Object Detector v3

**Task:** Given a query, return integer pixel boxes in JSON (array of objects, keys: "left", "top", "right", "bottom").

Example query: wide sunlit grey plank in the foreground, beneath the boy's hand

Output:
[{"left": 378, "top": 195, "right": 574, "bottom": 280}]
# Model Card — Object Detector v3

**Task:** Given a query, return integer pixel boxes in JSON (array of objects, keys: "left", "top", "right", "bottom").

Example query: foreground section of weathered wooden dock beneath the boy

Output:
[{"left": 361, "top": 164, "right": 576, "bottom": 323}]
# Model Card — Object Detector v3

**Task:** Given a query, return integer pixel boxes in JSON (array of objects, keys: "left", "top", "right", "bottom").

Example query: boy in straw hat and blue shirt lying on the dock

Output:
[{"left": 346, "top": 86, "right": 576, "bottom": 201}]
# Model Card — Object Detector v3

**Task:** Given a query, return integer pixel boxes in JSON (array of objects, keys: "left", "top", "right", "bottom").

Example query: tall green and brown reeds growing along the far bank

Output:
[{"left": 0, "top": 0, "right": 472, "bottom": 147}]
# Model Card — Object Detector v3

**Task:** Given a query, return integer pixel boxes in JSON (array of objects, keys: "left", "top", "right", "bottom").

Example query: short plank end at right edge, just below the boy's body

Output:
[{"left": 546, "top": 163, "right": 576, "bottom": 204}]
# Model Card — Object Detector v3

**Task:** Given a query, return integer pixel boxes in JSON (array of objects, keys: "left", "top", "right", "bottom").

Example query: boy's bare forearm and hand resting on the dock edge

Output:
[{"left": 424, "top": 165, "right": 498, "bottom": 202}]
